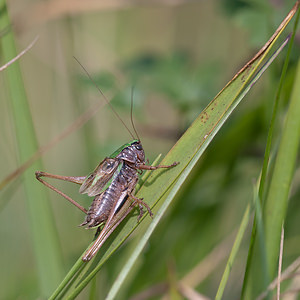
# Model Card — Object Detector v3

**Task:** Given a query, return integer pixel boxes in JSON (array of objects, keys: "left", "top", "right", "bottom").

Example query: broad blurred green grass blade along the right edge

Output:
[{"left": 264, "top": 56, "right": 300, "bottom": 284}]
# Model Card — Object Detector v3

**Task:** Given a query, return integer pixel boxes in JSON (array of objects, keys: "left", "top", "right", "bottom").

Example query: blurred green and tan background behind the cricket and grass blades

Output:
[{"left": 0, "top": 0, "right": 300, "bottom": 299}]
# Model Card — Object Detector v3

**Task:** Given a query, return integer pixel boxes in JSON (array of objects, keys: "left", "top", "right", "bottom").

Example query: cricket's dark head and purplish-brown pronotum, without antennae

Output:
[{"left": 115, "top": 140, "right": 145, "bottom": 164}]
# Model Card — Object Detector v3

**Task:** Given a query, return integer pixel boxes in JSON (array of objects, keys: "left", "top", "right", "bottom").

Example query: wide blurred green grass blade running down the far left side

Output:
[{"left": 0, "top": 1, "right": 62, "bottom": 296}]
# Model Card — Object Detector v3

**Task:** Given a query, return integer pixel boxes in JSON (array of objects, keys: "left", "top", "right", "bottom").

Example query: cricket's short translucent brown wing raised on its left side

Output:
[{"left": 79, "top": 158, "right": 121, "bottom": 197}]
